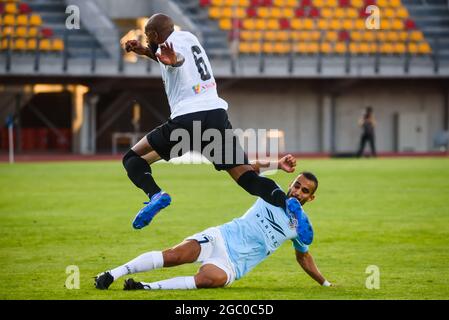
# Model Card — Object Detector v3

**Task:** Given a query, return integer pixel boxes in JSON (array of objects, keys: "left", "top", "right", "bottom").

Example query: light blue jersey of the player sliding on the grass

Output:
[{"left": 218, "top": 198, "right": 308, "bottom": 279}]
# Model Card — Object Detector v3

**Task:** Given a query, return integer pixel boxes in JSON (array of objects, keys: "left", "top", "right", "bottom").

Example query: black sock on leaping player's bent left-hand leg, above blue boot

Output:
[{"left": 123, "top": 150, "right": 161, "bottom": 198}]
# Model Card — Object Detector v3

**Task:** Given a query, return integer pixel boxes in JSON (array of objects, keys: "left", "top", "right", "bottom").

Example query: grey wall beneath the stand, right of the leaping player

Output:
[{"left": 219, "top": 79, "right": 448, "bottom": 153}]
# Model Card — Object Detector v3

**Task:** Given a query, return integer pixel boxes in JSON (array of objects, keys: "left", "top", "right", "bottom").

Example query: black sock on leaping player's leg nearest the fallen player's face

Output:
[{"left": 237, "top": 170, "right": 287, "bottom": 210}]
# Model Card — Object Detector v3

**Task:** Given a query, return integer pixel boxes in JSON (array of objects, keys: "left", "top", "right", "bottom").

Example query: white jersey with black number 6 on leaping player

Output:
[{"left": 157, "top": 31, "right": 228, "bottom": 119}]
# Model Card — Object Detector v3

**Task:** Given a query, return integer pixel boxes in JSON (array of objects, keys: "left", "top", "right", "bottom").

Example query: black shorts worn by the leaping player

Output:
[{"left": 147, "top": 109, "right": 249, "bottom": 170}]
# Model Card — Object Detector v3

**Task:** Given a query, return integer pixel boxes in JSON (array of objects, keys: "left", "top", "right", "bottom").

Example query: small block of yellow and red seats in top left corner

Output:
[{"left": 0, "top": 0, "right": 64, "bottom": 52}]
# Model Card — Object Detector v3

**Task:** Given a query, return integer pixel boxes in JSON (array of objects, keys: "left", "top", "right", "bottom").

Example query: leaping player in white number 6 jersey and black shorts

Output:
[{"left": 123, "top": 14, "right": 298, "bottom": 229}]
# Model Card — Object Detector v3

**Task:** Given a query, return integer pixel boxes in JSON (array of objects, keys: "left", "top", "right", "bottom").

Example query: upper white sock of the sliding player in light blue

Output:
[{"left": 109, "top": 251, "right": 164, "bottom": 280}]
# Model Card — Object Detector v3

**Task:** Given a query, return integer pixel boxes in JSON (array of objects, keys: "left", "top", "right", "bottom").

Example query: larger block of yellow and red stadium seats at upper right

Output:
[{"left": 199, "top": 0, "right": 432, "bottom": 55}]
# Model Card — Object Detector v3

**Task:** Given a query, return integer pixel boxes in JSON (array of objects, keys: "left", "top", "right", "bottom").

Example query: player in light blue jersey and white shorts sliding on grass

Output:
[{"left": 95, "top": 157, "right": 331, "bottom": 290}]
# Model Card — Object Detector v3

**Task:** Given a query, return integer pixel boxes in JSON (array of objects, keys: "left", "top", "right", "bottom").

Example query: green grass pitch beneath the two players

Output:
[{"left": 0, "top": 158, "right": 449, "bottom": 299}]
